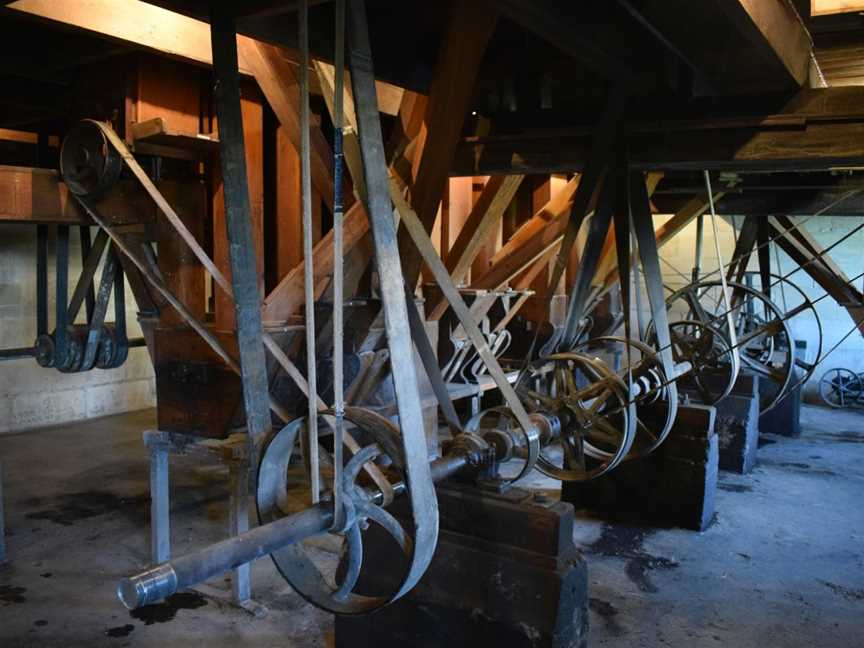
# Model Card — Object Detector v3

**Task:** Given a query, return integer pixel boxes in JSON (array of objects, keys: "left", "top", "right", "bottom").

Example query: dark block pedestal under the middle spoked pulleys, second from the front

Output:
[{"left": 561, "top": 405, "right": 719, "bottom": 531}]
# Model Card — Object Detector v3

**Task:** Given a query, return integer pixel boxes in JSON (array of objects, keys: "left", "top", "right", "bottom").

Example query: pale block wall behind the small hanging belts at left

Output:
[{"left": 0, "top": 224, "right": 156, "bottom": 433}]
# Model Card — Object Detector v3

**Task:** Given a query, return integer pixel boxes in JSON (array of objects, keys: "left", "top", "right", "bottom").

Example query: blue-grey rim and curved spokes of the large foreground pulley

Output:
[{"left": 256, "top": 407, "right": 413, "bottom": 615}]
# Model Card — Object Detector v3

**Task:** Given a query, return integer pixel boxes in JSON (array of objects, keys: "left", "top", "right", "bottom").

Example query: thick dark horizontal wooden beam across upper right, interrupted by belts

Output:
[{"left": 452, "top": 87, "right": 864, "bottom": 176}]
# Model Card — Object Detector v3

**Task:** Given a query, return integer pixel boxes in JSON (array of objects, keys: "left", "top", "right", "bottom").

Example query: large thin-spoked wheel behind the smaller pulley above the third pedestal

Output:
[{"left": 666, "top": 281, "right": 795, "bottom": 413}]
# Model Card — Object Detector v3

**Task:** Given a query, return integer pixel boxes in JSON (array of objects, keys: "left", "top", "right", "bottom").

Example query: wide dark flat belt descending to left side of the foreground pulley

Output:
[{"left": 210, "top": 2, "right": 271, "bottom": 474}]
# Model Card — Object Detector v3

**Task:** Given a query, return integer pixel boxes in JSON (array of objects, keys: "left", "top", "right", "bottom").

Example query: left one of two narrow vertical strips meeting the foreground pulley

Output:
[{"left": 297, "top": 0, "right": 321, "bottom": 504}]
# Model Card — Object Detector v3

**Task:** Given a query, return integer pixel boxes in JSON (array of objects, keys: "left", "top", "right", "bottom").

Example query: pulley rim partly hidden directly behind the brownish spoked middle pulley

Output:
[{"left": 576, "top": 335, "right": 678, "bottom": 461}]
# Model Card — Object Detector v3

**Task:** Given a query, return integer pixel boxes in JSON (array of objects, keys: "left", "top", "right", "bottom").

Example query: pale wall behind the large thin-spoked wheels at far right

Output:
[{"left": 655, "top": 215, "right": 864, "bottom": 398}]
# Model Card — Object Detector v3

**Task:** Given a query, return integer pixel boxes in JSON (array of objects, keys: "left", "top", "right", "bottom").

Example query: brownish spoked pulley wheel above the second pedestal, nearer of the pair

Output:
[{"left": 516, "top": 352, "right": 636, "bottom": 481}]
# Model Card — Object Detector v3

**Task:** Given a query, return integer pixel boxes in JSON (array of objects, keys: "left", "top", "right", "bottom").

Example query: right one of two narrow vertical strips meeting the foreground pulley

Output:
[{"left": 333, "top": 0, "right": 345, "bottom": 528}]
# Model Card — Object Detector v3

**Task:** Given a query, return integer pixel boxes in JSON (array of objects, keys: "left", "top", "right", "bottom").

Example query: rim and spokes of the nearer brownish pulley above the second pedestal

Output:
[{"left": 516, "top": 351, "right": 636, "bottom": 481}]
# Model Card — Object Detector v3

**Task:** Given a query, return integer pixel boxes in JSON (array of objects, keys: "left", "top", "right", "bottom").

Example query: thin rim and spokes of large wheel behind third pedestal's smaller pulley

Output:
[{"left": 666, "top": 280, "right": 795, "bottom": 414}]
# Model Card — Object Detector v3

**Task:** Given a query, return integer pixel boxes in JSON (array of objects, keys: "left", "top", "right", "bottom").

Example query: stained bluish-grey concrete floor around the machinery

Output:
[{"left": 0, "top": 407, "right": 864, "bottom": 648}]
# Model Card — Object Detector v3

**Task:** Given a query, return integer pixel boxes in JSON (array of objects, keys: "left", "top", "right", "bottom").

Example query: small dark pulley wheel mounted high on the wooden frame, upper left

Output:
[{"left": 60, "top": 119, "right": 123, "bottom": 198}]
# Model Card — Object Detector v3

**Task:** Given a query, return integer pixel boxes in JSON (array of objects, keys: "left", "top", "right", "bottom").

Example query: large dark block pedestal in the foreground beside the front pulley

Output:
[{"left": 336, "top": 484, "right": 588, "bottom": 648}]
